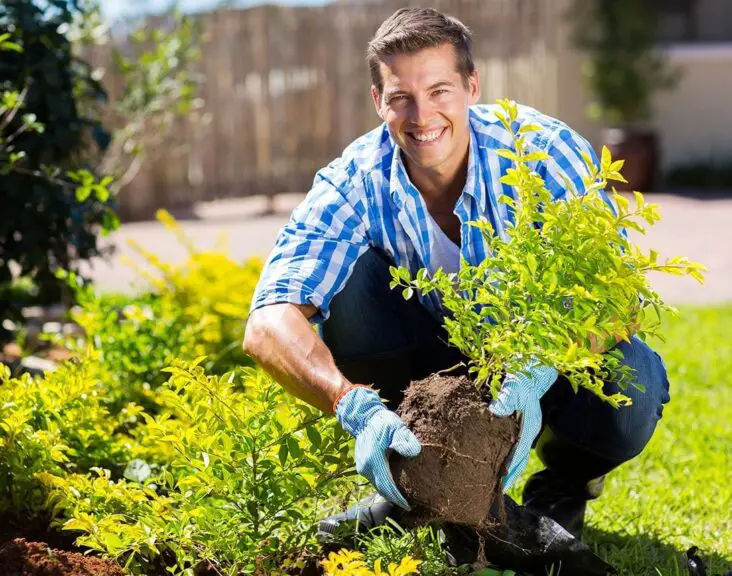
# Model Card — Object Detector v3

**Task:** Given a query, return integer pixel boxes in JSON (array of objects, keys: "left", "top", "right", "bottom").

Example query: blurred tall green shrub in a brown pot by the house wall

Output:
[{"left": 568, "top": 0, "right": 677, "bottom": 191}]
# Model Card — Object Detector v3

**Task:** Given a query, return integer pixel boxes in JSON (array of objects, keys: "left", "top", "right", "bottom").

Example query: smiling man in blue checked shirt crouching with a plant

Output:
[{"left": 244, "top": 8, "right": 669, "bottom": 560}]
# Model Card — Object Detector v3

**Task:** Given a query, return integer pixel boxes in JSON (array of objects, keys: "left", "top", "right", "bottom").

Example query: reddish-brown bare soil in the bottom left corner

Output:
[{"left": 0, "top": 538, "right": 125, "bottom": 576}]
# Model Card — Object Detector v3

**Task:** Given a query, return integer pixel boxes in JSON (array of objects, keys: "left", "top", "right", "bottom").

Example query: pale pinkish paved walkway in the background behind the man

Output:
[{"left": 84, "top": 194, "right": 732, "bottom": 304}]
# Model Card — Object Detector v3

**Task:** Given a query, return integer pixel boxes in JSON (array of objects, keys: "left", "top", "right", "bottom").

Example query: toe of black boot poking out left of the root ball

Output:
[{"left": 316, "top": 494, "right": 394, "bottom": 545}]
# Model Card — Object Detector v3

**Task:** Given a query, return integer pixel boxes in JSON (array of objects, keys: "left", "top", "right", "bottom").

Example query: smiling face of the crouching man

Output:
[{"left": 371, "top": 44, "right": 480, "bottom": 172}]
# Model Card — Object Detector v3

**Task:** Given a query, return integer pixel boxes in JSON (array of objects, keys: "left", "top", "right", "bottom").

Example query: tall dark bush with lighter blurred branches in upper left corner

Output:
[{"left": 0, "top": 0, "right": 201, "bottom": 315}]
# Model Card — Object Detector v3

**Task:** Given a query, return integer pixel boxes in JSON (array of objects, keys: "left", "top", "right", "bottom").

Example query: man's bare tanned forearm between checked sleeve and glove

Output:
[{"left": 244, "top": 304, "right": 351, "bottom": 413}]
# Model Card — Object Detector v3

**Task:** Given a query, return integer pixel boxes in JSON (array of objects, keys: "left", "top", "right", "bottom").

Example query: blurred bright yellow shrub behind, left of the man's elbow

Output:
[{"left": 56, "top": 211, "right": 261, "bottom": 412}]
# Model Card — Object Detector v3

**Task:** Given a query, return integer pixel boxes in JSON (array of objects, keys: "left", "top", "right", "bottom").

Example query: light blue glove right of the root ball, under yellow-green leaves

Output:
[{"left": 488, "top": 365, "right": 559, "bottom": 492}]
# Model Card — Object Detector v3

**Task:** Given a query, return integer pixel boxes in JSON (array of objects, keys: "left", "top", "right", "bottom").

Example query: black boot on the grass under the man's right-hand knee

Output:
[{"left": 522, "top": 427, "right": 620, "bottom": 540}]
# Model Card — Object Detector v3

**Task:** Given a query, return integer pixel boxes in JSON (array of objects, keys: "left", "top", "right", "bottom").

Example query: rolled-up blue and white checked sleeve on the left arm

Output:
[{"left": 251, "top": 165, "right": 368, "bottom": 323}]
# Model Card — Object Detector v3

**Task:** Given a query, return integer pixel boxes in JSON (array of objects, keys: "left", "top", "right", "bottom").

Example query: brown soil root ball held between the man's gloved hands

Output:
[{"left": 391, "top": 375, "right": 519, "bottom": 528}]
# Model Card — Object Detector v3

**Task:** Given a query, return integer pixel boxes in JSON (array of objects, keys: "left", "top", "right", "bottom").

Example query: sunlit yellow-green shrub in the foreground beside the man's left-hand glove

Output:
[{"left": 43, "top": 359, "right": 352, "bottom": 576}]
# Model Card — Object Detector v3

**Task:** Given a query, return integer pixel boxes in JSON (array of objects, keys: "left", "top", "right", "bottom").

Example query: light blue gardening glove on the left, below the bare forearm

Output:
[{"left": 335, "top": 386, "right": 422, "bottom": 510}]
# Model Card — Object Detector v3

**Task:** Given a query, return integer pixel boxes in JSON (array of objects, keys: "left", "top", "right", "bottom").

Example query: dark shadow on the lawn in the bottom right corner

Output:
[{"left": 584, "top": 526, "right": 732, "bottom": 576}]
